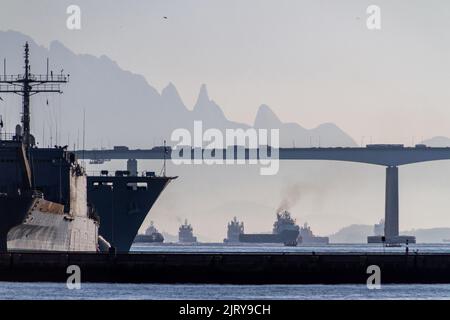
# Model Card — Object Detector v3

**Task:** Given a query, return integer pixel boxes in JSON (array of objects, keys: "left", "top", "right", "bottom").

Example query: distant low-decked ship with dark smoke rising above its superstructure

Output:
[{"left": 239, "top": 210, "right": 299, "bottom": 246}]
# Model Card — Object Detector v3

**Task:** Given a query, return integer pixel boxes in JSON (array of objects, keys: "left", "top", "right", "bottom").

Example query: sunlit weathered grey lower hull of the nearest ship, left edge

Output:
[{"left": 0, "top": 196, "right": 98, "bottom": 252}]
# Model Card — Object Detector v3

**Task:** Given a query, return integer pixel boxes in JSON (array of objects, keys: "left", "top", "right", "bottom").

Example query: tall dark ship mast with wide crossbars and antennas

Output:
[{"left": 0, "top": 42, "right": 69, "bottom": 148}]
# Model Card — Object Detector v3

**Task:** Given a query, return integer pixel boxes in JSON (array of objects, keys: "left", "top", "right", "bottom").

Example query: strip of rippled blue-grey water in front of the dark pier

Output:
[{"left": 0, "top": 282, "right": 450, "bottom": 300}]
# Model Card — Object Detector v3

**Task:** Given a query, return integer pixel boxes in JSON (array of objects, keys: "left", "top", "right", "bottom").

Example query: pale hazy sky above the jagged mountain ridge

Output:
[{"left": 0, "top": 0, "right": 450, "bottom": 144}]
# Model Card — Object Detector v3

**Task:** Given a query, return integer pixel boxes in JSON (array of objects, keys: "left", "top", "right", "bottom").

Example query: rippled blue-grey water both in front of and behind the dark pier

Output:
[{"left": 0, "top": 244, "right": 450, "bottom": 300}]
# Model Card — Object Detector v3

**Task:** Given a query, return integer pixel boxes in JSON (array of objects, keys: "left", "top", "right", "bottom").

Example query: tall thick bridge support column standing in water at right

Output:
[{"left": 384, "top": 166, "right": 399, "bottom": 238}]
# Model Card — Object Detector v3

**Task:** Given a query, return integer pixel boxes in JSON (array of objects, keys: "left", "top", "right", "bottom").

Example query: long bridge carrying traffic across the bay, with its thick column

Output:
[{"left": 76, "top": 144, "right": 450, "bottom": 243}]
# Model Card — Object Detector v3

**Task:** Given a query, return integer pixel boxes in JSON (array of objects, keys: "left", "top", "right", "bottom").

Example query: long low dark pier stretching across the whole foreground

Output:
[{"left": 0, "top": 253, "right": 450, "bottom": 285}]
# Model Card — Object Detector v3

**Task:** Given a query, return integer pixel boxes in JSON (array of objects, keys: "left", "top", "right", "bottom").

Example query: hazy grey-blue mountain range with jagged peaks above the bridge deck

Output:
[{"left": 0, "top": 31, "right": 356, "bottom": 148}]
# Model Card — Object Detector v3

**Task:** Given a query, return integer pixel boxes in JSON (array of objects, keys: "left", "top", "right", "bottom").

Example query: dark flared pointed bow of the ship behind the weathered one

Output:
[{"left": 87, "top": 176, "right": 172, "bottom": 252}]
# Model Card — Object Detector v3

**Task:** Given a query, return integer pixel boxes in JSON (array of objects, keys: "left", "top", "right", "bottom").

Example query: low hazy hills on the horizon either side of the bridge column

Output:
[{"left": 330, "top": 224, "right": 450, "bottom": 243}]
